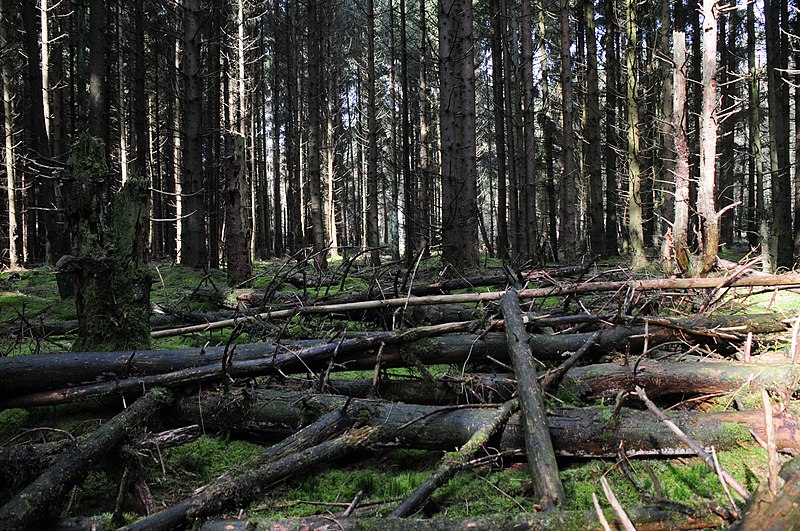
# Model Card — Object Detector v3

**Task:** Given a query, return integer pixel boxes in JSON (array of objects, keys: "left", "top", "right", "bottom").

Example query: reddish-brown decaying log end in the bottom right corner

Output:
[{"left": 731, "top": 457, "right": 800, "bottom": 531}]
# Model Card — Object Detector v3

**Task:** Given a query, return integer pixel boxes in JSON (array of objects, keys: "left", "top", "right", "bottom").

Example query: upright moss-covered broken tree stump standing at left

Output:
[{"left": 57, "top": 134, "right": 152, "bottom": 352}]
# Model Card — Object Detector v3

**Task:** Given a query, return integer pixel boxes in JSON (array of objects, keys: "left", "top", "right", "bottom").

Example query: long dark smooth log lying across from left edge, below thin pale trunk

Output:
[{"left": 0, "top": 315, "right": 786, "bottom": 407}]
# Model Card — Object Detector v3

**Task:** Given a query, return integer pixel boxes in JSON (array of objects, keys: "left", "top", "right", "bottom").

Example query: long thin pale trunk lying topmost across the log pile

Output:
[{"left": 152, "top": 273, "right": 800, "bottom": 337}]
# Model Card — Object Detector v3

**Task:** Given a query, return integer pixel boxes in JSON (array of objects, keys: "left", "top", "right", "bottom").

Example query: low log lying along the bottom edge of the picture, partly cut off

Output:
[{"left": 195, "top": 506, "right": 726, "bottom": 531}]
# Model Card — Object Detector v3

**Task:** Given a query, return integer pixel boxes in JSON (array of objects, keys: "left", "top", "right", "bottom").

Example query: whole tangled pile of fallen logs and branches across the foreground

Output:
[{"left": 0, "top": 275, "right": 800, "bottom": 529}]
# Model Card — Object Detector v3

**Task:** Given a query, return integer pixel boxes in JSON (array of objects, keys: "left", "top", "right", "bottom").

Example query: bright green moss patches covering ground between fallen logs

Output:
[{"left": 0, "top": 261, "right": 800, "bottom": 517}]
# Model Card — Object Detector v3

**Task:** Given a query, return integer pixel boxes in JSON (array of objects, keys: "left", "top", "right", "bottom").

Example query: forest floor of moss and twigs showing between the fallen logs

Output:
[{"left": 0, "top": 252, "right": 800, "bottom": 525}]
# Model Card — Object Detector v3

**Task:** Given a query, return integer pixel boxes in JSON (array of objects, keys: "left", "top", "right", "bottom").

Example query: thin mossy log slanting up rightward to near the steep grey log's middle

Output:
[{"left": 391, "top": 400, "right": 520, "bottom": 518}]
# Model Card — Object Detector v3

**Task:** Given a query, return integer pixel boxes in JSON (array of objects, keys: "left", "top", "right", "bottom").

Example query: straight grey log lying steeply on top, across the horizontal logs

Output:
[{"left": 503, "top": 289, "right": 564, "bottom": 509}]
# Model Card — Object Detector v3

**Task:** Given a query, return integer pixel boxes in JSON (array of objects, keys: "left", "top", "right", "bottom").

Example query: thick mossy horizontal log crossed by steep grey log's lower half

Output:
[{"left": 166, "top": 389, "right": 800, "bottom": 457}]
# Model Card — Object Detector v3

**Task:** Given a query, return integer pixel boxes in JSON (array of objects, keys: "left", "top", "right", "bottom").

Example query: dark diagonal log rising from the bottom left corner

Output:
[{"left": 0, "top": 389, "right": 173, "bottom": 530}]
